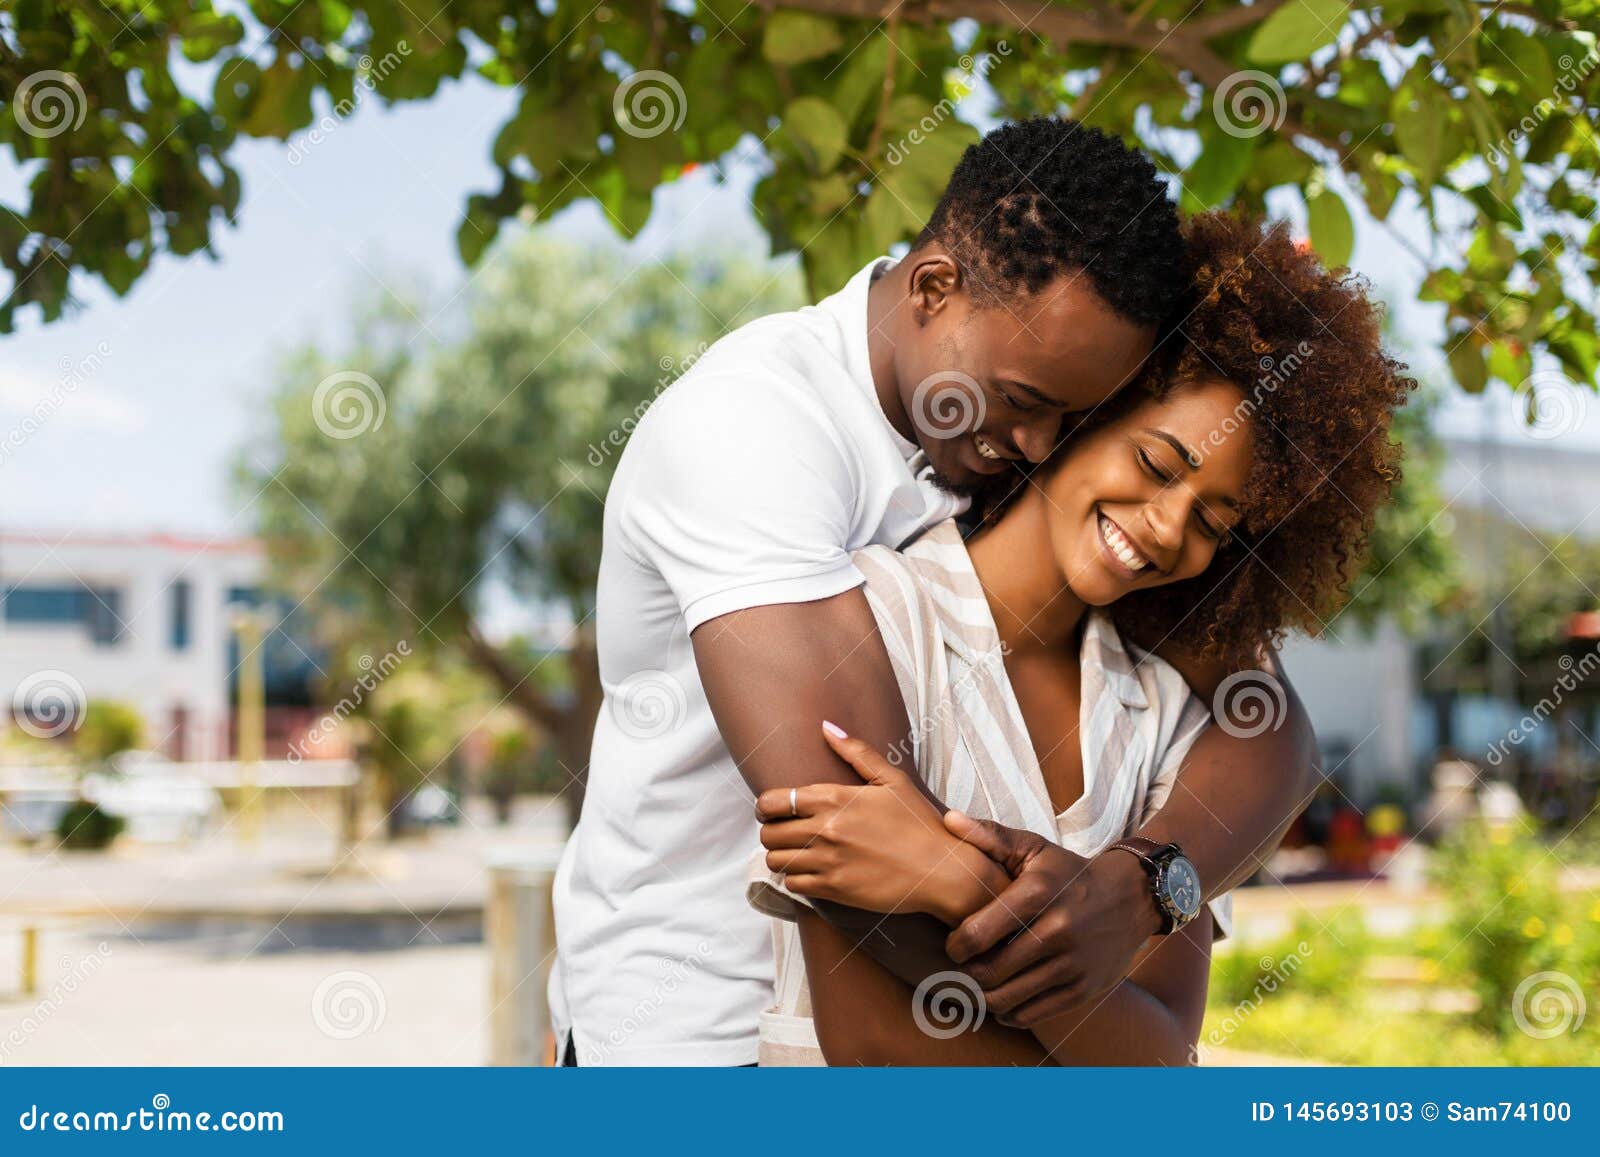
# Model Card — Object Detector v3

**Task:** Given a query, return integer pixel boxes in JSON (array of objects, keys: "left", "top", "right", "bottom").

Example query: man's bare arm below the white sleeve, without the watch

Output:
[{"left": 691, "top": 589, "right": 1006, "bottom": 984}]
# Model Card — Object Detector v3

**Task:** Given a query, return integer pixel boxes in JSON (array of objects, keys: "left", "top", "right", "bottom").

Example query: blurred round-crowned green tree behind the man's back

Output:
[{"left": 242, "top": 234, "right": 800, "bottom": 816}]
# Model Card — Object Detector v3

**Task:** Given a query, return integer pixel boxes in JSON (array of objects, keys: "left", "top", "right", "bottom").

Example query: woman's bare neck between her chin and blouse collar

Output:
[{"left": 966, "top": 485, "right": 1086, "bottom": 653}]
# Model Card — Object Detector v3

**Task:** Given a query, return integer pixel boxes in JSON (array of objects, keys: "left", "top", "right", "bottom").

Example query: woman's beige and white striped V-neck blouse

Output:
[{"left": 747, "top": 522, "right": 1232, "bottom": 1066}]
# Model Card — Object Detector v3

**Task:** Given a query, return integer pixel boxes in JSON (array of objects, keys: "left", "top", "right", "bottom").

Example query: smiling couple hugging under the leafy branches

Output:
[{"left": 550, "top": 118, "right": 1413, "bottom": 1066}]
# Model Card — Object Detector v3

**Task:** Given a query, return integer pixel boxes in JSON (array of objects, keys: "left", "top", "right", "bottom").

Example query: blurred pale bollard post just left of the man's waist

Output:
[{"left": 483, "top": 847, "right": 562, "bottom": 1064}]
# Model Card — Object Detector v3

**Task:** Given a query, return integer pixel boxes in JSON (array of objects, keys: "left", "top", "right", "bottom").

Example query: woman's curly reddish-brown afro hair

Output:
[{"left": 1114, "top": 213, "right": 1416, "bottom": 666}]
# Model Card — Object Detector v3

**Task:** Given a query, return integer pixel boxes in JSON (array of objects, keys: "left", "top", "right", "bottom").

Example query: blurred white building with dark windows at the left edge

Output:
[{"left": 0, "top": 533, "right": 317, "bottom": 760}]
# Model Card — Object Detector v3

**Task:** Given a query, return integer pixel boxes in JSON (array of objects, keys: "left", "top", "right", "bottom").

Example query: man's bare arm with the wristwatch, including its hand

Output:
[{"left": 946, "top": 656, "right": 1317, "bottom": 1026}]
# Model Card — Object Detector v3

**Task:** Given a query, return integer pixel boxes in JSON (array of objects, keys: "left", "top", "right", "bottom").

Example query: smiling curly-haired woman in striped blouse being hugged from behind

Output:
[{"left": 750, "top": 214, "right": 1413, "bottom": 1064}]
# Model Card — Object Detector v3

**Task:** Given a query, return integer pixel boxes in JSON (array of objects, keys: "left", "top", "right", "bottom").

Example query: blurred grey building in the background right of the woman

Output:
[{"left": 1283, "top": 438, "right": 1600, "bottom": 807}]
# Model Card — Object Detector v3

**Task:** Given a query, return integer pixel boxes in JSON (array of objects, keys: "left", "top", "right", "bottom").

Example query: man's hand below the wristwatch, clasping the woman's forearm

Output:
[{"left": 944, "top": 811, "right": 1162, "bottom": 1027}]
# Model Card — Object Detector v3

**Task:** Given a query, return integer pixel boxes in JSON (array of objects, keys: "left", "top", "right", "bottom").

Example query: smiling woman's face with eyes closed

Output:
[{"left": 1043, "top": 381, "right": 1253, "bottom": 607}]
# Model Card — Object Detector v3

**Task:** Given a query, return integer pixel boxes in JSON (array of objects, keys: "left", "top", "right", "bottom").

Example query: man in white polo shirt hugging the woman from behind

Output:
[{"left": 550, "top": 118, "right": 1309, "bottom": 1064}]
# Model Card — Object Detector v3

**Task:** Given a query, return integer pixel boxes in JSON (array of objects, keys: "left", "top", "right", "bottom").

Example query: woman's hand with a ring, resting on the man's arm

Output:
[{"left": 755, "top": 725, "right": 1010, "bottom": 925}]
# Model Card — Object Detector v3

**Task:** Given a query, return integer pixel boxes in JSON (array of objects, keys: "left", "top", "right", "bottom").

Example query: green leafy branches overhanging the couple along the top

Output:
[{"left": 0, "top": 0, "right": 1600, "bottom": 416}]
